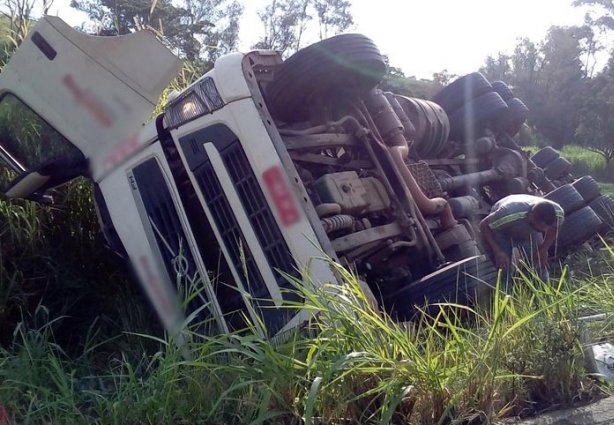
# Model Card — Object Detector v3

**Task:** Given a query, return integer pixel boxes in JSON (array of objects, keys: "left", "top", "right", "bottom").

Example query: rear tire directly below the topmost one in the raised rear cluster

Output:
[{"left": 450, "top": 92, "right": 508, "bottom": 141}]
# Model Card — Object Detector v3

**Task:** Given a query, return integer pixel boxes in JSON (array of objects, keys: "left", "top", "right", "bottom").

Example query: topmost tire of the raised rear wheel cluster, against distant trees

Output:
[{"left": 433, "top": 72, "right": 492, "bottom": 114}]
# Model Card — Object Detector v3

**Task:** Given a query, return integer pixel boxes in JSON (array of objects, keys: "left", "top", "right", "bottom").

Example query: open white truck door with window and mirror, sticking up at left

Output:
[{"left": 0, "top": 16, "right": 180, "bottom": 197}]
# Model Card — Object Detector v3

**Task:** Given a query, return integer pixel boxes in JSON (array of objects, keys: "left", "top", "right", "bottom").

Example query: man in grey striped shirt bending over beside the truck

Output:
[{"left": 480, "top": 195, "right": 565, "bottom": 282}]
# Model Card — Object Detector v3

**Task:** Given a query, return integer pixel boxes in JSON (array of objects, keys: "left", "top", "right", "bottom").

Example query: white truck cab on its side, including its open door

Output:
[{"left": 0, "top": 16, "right": 342, "bottom": 334}]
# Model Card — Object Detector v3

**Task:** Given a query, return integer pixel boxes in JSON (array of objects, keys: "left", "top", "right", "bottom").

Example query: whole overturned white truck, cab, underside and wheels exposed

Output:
[{"left": 0, "top": 17, "right": 612, "bottom": 335}]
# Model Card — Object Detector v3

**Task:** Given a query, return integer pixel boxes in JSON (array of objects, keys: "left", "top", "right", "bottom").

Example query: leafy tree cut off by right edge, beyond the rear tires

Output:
[{"left": 576, "top": 52, "right": 614, "bottom": 165}]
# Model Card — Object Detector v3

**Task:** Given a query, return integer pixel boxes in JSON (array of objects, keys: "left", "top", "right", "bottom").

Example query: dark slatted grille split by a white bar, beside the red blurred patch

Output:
[{"left": 179, "top": 124, "right": 301, "bottom": 335}]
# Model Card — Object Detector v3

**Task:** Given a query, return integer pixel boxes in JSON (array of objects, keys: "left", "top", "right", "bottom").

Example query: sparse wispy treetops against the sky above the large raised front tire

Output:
[{"left": 254, "top": 0, "right": 354, "bottom": 55}]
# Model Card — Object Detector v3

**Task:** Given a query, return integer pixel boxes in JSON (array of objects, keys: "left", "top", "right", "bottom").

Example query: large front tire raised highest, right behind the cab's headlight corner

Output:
[{"left": 266, "top": 34, "right": 386, "bottom": 122}]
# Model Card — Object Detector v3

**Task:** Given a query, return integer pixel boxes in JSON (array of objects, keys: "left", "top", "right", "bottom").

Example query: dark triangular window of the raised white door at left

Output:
[{"left": 0, "top": 94, "right": 83, "bottom": 183}]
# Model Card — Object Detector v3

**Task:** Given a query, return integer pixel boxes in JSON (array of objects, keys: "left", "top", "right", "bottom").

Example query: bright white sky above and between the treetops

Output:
[{"left": 43, "top": 0, "right": 586, "bottom": 78}]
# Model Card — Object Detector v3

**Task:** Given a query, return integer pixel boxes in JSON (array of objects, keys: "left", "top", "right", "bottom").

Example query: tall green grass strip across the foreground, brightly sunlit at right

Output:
[{"left": 0, "top": 256, "right": 614, "bottom": 424}]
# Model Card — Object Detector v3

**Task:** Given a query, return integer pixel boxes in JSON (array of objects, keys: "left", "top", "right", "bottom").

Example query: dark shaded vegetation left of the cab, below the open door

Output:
[{"left": 0, "top": 179, "right": 159, "bottom": 354}]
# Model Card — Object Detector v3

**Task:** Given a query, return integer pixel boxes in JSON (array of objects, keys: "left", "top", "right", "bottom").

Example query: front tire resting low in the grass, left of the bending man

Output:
[{"left": 383, "top": 256, "right": 498, "bottom": 320}]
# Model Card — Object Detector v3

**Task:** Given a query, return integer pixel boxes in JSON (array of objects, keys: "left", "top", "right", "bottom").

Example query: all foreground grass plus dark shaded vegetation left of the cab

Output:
[{"left": 0, "top": 144, "right": 614, "bottom": 424}]
